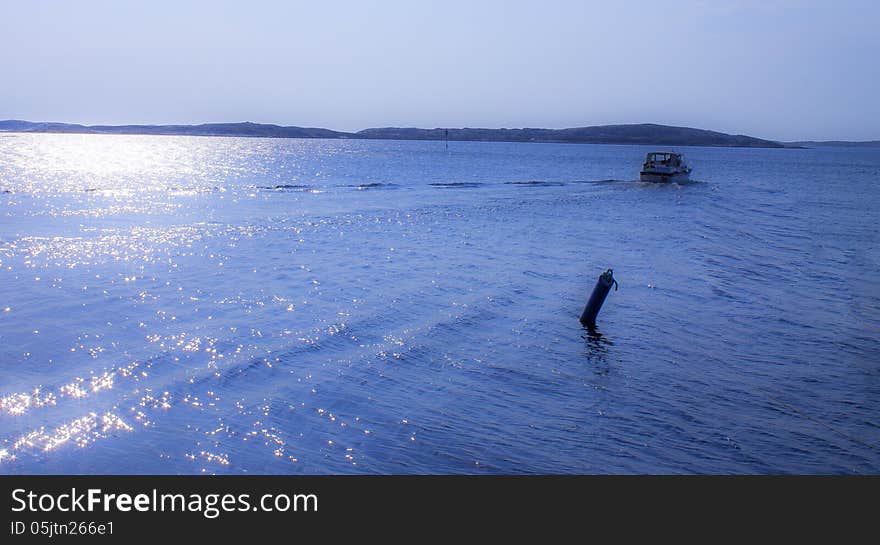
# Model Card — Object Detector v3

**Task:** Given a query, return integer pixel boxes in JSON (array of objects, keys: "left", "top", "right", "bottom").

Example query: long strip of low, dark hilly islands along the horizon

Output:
[{"left": 0, "top": 120, "right": 880, "bottom": 148}]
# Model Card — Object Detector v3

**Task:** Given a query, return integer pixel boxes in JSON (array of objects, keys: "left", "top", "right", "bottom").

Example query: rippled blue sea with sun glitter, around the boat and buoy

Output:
[{"left": 0, "top": 134, "right": 880, "bottom": 473}]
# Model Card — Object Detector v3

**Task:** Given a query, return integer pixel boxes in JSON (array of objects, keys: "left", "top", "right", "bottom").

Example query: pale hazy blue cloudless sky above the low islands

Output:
[{"left": 0, "top": 0, "right": 880, "bottom": 140}]
